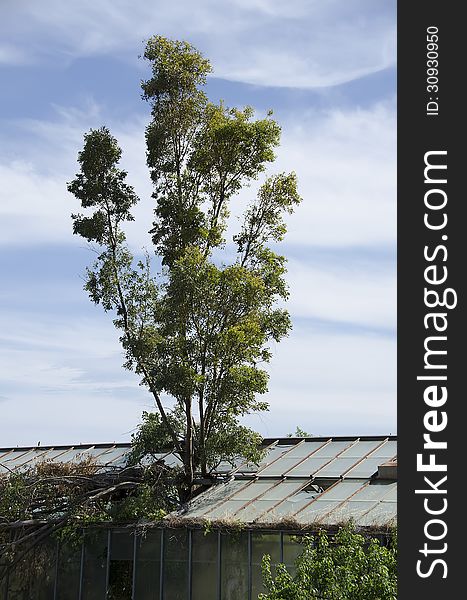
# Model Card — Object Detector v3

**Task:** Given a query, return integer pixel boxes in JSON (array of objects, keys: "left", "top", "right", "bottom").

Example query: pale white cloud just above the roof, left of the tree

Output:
[{"left": 0, "top": 310, "right": 152, "bottom": 446}]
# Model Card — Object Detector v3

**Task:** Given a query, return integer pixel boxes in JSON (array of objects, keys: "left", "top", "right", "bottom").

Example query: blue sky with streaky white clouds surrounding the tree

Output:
[{"left": 0, "top": 0, "right": 396, "bottom": 447}]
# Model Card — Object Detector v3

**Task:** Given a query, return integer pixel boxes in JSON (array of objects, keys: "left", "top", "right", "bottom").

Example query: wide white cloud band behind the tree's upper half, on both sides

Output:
[{"left": 0, "top": 100, "right": 396, "bottom": 249}]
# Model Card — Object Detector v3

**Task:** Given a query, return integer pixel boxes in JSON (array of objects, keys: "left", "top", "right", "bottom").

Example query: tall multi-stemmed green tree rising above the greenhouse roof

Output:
[{"left": 68, "top": 36, "right": 300, "bottom": 499}]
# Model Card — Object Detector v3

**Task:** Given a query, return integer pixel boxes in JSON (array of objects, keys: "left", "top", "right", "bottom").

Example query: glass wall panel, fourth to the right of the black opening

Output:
[{"left": 221, "top": 531, "right": 248, "bottom": 600}]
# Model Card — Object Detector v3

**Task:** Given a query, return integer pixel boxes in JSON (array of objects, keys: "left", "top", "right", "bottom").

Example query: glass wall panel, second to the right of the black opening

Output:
[{"left": 164, "top": 529, "right": 188, "bottom": 600}]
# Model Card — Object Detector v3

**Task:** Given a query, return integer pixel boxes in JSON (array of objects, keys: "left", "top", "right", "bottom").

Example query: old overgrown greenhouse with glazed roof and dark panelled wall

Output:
[{"left": 0, "top": 437, "right": 397, "bottom": 600}]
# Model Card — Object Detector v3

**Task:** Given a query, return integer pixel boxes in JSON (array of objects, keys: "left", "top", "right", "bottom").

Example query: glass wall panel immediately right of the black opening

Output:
[{"left": 135, "top": 529, "right": 161, "bottom": 600}]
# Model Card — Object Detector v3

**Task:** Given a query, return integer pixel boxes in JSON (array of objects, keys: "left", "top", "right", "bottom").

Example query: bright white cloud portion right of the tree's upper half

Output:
[{"left": 274, "top": 105, "right": 396, "bottom": 247}]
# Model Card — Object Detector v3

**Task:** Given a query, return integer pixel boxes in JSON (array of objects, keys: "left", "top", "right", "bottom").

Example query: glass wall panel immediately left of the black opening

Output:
[{"left": 82, "top": 530, "right": 107, "bottom": 600}]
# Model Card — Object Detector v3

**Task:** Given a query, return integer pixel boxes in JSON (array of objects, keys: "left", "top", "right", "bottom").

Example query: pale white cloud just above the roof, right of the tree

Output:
[{"left": 245, "top": 327, "right": 396, "bottom": 436}]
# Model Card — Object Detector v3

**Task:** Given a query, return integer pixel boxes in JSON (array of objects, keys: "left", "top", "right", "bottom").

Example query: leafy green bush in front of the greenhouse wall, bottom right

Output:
[{"left": 258, "top": 524, "right": 397, "bottom": 600}]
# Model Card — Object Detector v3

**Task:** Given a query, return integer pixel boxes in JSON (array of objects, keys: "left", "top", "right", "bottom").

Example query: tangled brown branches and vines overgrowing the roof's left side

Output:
[{"left": 0, "top": 459, "right": 178, "bottom": 582}]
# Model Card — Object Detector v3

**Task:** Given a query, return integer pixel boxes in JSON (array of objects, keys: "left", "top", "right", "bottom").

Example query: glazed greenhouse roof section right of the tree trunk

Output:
[{"left": 169, "top": 437, "right": 397, "bottom": 528}]
